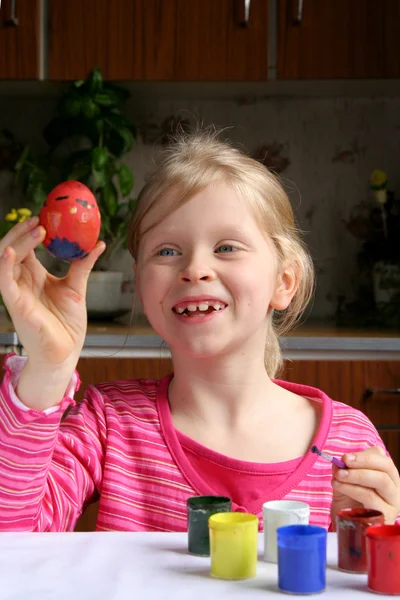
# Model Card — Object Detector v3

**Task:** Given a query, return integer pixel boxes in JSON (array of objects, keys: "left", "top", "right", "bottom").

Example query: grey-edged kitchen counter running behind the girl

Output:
[{"left": 0, "top": 315, "right": 400, "bottom": 360}]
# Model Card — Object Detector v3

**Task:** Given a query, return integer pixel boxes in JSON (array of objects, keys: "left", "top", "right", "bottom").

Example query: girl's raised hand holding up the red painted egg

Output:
[{"left": 0, "top": 217, "right": 105, "bottom": 372}]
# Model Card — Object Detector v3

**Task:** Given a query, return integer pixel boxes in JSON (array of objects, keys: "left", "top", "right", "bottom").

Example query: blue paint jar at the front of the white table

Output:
[{"left": 277, "top": 525, "right": 327, "bottom": 594}]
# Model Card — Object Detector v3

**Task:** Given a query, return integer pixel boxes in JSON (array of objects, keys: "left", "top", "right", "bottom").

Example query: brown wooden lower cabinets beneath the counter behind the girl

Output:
[{"left": 76, "top": 358, "right": 400, "bottom": 531}]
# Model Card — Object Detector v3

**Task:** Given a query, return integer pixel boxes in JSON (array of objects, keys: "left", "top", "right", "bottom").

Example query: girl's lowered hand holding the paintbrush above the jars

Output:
[{"left": 331, "top": 446, "right": 400, "bottom": 524}]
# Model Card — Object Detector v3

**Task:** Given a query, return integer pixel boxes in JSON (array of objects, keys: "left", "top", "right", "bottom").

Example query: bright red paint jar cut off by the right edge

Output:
[{"left": 366, "top": 525, "right": 400, "bottom": 594}]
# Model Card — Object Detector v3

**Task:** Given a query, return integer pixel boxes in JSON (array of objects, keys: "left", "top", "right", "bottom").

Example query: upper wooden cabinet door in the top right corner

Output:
[{"left": 277, "top": 0, "right": 400, "bottom": 79}]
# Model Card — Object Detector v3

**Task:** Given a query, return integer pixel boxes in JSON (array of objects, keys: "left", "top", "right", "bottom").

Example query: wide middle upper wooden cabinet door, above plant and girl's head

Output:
[{"left": 48, "top": 0, "right": 268, "bottom": 81}]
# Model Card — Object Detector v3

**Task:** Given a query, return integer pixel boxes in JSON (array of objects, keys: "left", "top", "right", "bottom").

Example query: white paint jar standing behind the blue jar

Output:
[{"left": 263, "top": 500, "right": 310, "bottom": 562}]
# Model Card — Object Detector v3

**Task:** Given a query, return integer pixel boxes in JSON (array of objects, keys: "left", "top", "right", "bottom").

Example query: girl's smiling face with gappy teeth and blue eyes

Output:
[{"left": 136, "top": 182, "right": 294, "bottom": 358}]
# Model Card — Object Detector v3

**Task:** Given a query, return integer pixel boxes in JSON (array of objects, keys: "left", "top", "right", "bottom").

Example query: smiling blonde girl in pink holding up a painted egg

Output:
[{"left": 0, "top": 134, "right": 400, "bottom": 531}]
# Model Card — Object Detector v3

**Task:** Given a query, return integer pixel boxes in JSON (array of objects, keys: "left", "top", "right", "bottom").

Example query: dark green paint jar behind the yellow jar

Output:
[{"left": 186, "top": 496, "right": 232, "bottom": 556}]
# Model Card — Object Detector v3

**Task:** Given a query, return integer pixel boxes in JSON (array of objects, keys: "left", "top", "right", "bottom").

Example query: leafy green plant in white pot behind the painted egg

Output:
[{"left": 9, "top": 68, "right": 136, "bottom": 314}]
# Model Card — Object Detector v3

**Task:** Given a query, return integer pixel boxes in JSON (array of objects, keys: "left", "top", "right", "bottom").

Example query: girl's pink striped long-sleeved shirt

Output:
[{"left": 0, "top": 355, "right": 384, "bottom": 531}]
